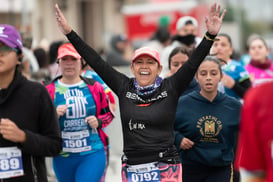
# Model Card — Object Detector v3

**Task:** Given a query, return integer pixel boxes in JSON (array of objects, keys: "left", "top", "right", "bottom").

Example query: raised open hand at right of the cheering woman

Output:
[{"left": 205, "top": 3, "right": 226, "bottom": 35}]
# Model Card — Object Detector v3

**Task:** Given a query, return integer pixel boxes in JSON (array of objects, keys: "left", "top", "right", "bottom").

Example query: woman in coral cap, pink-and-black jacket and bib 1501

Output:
[{"left": 43, "top": 43, "right": 113, "bottom": 182}]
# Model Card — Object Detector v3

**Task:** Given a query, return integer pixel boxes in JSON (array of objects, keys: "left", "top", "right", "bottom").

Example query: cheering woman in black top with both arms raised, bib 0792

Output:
[{"left": 56, "top": 3, "right": 225, "bottom": 182}]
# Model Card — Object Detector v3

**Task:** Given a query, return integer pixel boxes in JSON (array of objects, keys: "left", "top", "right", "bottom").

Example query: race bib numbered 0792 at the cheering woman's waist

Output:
[{"left": 127, "top": 163, "right": 161, "bottom": 182}]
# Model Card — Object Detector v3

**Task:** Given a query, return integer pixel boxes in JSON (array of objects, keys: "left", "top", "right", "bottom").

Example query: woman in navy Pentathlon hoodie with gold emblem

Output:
[{"left": 175, "top": 56, "right": 241, "bottom": 182}]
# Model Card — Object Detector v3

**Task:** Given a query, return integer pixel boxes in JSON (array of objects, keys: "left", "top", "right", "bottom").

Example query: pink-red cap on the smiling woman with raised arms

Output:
[{"left": 132, "top": 47, "right": 161, "bottom": 65}]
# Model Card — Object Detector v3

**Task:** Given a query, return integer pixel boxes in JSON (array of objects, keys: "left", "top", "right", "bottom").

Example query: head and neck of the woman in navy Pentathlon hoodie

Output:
[{"left": 196, "top": 60, "right": 222, "bottom": 95}]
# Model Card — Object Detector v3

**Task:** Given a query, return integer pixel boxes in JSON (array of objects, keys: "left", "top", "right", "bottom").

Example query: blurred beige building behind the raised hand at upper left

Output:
[{"left": 0, "top": 0, "right": 124, "bottom": 47}]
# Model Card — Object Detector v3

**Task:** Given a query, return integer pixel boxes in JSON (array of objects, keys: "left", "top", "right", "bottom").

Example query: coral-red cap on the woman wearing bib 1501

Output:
[{"left": 57, "top": 43, "right": 81, "bottom": 59}]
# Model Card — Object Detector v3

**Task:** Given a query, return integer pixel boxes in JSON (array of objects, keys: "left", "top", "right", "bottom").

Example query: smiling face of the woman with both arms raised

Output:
[{"left": 131, "top": 55, "right": 162, "bottom": 87}]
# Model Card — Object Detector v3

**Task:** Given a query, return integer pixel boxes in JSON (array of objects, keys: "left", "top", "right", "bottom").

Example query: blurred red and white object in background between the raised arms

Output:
[{"left": 123, "top": 0, "right": 209, "bottom": 41}]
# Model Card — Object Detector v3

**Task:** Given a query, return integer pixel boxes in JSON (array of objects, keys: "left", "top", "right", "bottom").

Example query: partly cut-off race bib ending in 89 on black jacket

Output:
[{"left": 0, "top": 147, "right": 24, "bottom": 179}]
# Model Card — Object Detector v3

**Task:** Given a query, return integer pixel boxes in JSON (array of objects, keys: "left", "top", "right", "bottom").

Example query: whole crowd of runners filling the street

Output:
[{"left": 0, "top": 3, "right": 273, "bottom": 182}]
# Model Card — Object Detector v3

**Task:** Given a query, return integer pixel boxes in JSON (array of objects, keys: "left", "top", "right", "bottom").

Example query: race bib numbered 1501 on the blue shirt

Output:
[{"left": 62, "top": 130, "right": 91, "bottom": 153}]
